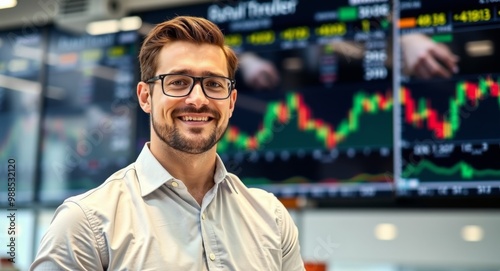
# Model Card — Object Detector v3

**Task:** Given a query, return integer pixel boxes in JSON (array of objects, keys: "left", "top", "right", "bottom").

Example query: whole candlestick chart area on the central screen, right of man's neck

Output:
[{"left": 218, "top": 85, "right": 393, "bottom": 196}]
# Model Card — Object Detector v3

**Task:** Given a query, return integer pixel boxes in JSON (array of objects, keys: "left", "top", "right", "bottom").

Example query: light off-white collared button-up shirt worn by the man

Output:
[{"left": 30, "top": 144, "right": 304, "bottom": 271}]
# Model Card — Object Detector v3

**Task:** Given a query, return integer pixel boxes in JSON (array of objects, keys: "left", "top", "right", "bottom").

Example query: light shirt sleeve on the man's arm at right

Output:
[{"left": 276, "top": 200, "right": 305, "bottom": 271}]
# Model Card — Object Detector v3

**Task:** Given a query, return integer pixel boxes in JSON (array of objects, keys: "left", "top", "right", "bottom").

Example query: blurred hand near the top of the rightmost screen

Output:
[{"left": 401, "top": 34, "right": 459, "bottom": 79}]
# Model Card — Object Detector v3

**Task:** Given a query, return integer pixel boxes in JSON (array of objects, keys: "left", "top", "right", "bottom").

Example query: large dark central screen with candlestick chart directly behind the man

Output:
[{"left": 137, "top": 0, "right": 394, "bottom": 199}]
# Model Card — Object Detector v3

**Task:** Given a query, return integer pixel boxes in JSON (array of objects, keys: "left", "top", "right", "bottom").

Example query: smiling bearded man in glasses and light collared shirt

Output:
[{"left": 30, "top": 17, "right": 304, "bottom": 271}]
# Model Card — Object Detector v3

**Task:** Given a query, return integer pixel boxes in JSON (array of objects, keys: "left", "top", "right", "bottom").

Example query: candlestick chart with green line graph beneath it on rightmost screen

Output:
[{"left": 400, "top": 75, "right": 500, "bottom": 192}]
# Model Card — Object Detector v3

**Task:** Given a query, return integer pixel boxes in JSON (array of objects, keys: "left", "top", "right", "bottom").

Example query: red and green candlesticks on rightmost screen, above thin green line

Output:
[{"left": 400, "top": 77, "right": 500, "bottom": 140}]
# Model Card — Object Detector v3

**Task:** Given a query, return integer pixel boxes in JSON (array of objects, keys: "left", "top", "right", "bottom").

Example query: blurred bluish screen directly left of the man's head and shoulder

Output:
[{"left": 40, "top": 29, "right": 138, "bottom": 201}]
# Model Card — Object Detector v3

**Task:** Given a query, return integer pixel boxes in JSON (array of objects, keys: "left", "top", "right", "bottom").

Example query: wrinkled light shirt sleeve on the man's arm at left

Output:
[{"left": 29, "top": 201, "right": 105, "bottom": 271}]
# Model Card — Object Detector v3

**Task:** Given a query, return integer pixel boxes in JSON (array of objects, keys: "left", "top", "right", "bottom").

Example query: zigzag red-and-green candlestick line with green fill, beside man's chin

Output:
[{"left": 218, "top": 91, "right": 393, "bottom": 152}]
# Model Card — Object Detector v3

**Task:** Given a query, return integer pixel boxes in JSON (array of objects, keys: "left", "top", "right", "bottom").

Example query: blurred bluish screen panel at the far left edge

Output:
[{"left": 0, "top": 28, "right": 44, "bottom": 204}]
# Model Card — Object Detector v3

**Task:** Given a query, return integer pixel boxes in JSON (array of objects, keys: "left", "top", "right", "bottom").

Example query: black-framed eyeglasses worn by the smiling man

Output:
[{"left": 145, "top": 73, "right": 236, "bottom": 100}]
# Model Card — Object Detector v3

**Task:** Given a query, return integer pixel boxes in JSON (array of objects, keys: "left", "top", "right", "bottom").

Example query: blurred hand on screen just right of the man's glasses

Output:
[{"left": 239, "top": 52, "right": 280, "bottom": 90}]
